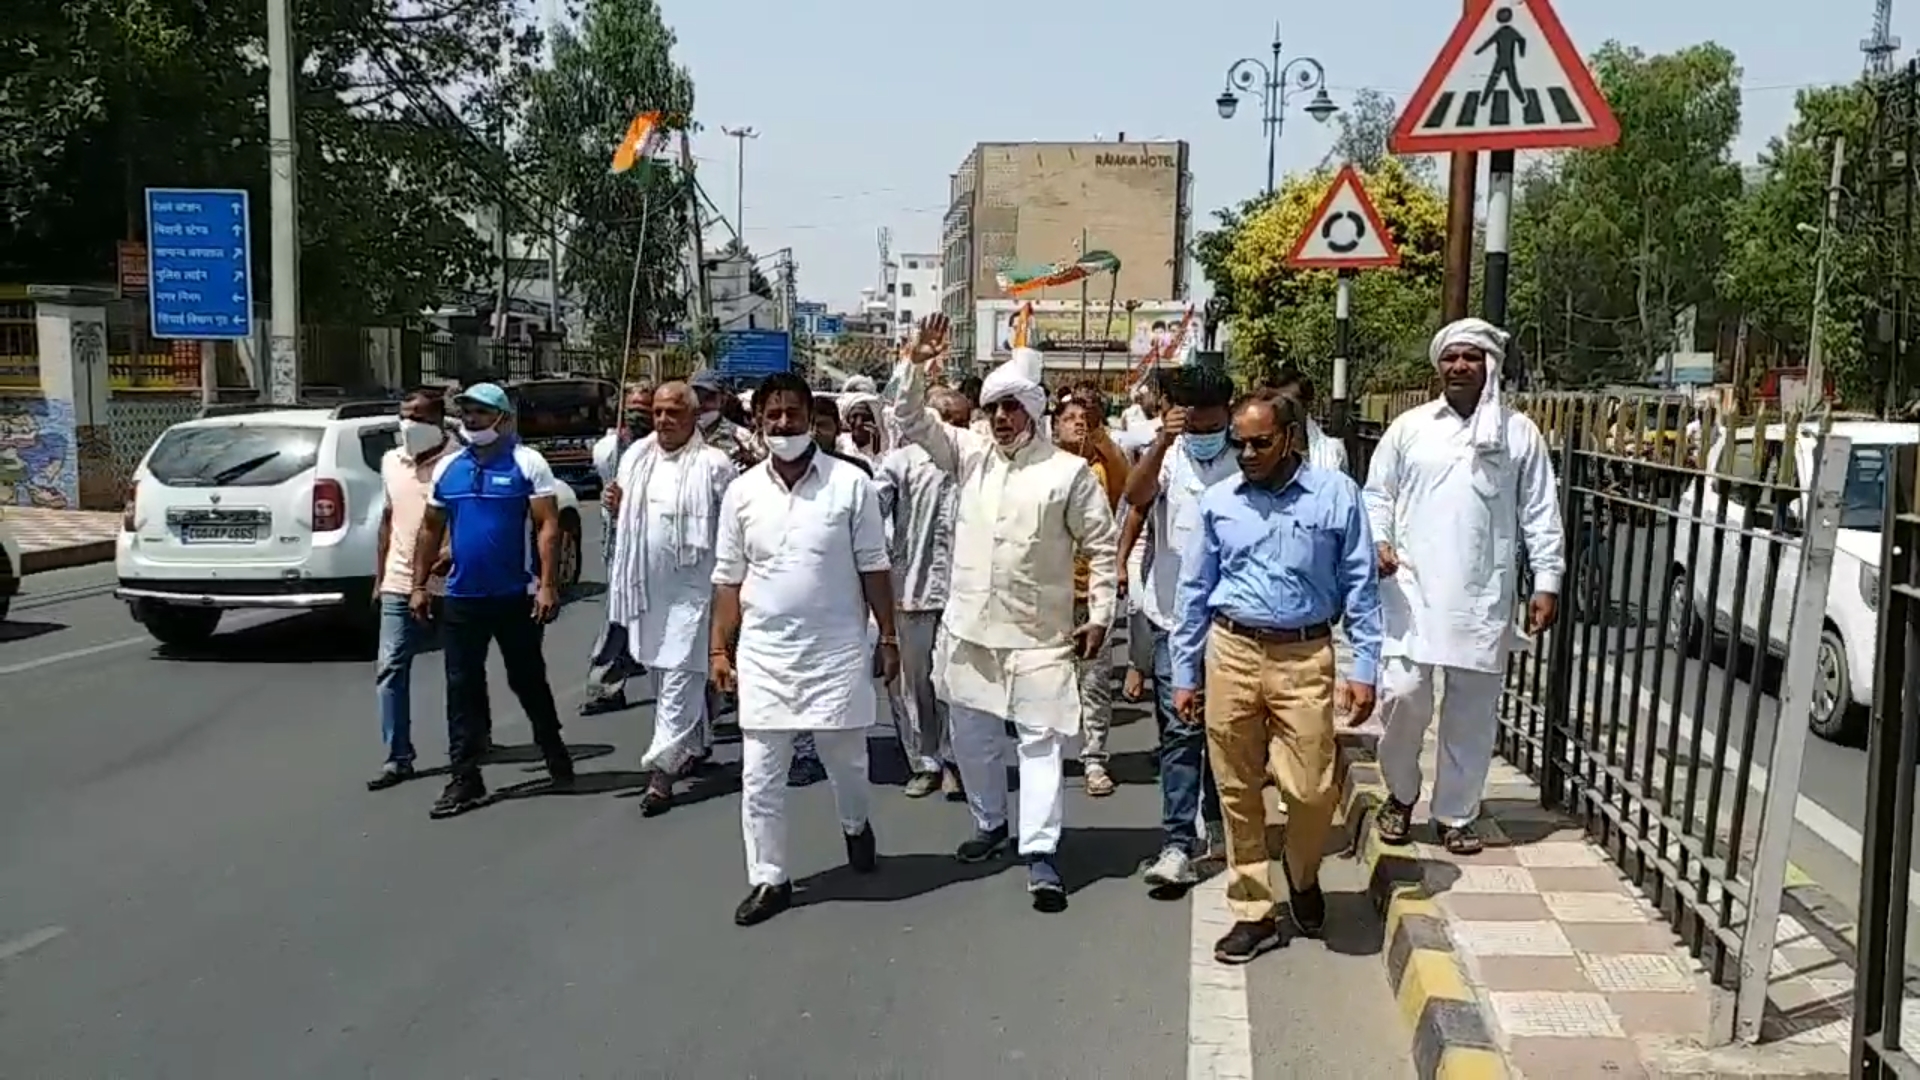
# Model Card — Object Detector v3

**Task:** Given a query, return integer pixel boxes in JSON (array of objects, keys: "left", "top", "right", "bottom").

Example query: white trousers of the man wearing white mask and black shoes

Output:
[{"left": 739, "top": 728, "right": 870, "bottom": 886}]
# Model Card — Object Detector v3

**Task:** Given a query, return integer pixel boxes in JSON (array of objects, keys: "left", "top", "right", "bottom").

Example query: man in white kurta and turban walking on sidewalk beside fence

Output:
[{"left": 1365, "top": 319, "right": 1565, "bottom": 855}]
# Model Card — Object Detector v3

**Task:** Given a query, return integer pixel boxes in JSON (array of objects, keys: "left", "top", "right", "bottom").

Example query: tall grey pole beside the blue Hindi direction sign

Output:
[{"left": 264, "top": 0, "right": 300, "bottom": 405}]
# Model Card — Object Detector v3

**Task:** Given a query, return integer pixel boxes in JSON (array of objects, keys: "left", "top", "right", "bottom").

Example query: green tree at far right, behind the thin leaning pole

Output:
[{"left": 1720, "top": 83, "right": 1880, "bottom": 402}]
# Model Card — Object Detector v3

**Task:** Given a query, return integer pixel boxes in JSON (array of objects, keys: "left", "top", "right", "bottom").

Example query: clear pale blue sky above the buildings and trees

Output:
[{"left": 648, "top": 0, "right": 1920, "bottom": 307}]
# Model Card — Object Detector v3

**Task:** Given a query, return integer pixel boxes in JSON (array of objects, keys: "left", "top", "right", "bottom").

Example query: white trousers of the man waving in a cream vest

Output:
[{"left": 947, "top": 705, "right": 1068, "bottom": 855}]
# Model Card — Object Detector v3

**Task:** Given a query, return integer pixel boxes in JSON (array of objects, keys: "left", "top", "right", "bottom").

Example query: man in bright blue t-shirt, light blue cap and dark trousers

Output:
[{"left": 409, "top": 382, "right": 574, "bottom": 817}]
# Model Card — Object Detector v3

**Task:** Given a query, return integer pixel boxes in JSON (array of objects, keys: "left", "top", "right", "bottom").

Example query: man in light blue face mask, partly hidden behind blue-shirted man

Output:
[{"left": 1119, "top": 367, "right": 1238, "bottom": 888}]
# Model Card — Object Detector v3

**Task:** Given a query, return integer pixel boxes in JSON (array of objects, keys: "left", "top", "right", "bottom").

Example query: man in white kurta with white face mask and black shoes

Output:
[{"left": 708, "top": 375, "right": 900, "bottom": 926}]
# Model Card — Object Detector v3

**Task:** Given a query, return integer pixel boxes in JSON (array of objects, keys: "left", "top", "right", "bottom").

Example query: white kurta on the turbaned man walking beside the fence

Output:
[{"left": 1365, "top": 400, "right": 1565, "bottom": 673}]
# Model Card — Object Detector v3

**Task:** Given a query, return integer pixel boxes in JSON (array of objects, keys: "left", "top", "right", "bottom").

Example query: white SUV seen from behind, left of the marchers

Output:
[{"left": 113, "top": 407, "right": 580, "bottom": 644}]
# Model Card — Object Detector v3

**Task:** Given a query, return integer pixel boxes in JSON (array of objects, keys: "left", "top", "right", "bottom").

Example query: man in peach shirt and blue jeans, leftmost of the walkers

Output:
[{"left": 367, "top": 390, "right": 451, "bottom": 792}]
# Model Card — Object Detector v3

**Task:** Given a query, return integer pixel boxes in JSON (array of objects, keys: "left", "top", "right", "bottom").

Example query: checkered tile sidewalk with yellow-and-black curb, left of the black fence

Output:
[{"left": 1346, "top": 722, "right": 1847, "bottom": 1080}]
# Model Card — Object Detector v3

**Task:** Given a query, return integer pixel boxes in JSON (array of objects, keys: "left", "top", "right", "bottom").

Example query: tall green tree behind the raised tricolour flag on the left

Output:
[{"left": 518, "top": 0, "right": 695, "bottom": 353}]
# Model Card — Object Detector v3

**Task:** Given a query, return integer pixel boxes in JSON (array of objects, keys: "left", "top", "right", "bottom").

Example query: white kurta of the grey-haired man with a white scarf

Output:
[{"left": 614, "top": 438, "right": 735, "bottom": 675}]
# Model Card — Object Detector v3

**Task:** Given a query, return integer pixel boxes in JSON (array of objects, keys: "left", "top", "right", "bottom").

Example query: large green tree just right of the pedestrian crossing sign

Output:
[{"left": 1509, "top": 42, "right": 1741, "bottom": 382}]
